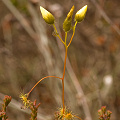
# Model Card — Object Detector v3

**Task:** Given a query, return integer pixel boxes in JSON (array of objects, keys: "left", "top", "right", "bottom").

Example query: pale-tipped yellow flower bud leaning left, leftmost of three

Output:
[{"left": 40, "top": 6, "right": 55, "bottom": 24}]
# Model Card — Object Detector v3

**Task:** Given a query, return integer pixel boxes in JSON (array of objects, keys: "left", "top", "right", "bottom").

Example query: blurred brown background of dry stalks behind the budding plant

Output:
[{"left": 0, "top": 0, "right": 120, "bottom": 120}]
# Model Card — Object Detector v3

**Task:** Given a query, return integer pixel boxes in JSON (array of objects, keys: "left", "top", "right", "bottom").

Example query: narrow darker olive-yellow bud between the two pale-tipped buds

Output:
[{"left": 63, "top": 6, "right": 74, "bottom": 32}]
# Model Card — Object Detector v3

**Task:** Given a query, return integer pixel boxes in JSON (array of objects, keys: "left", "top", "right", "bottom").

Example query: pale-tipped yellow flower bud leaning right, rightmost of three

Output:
[{"left": 75, "top": 5, "right": 87, "bottom": 22}]
